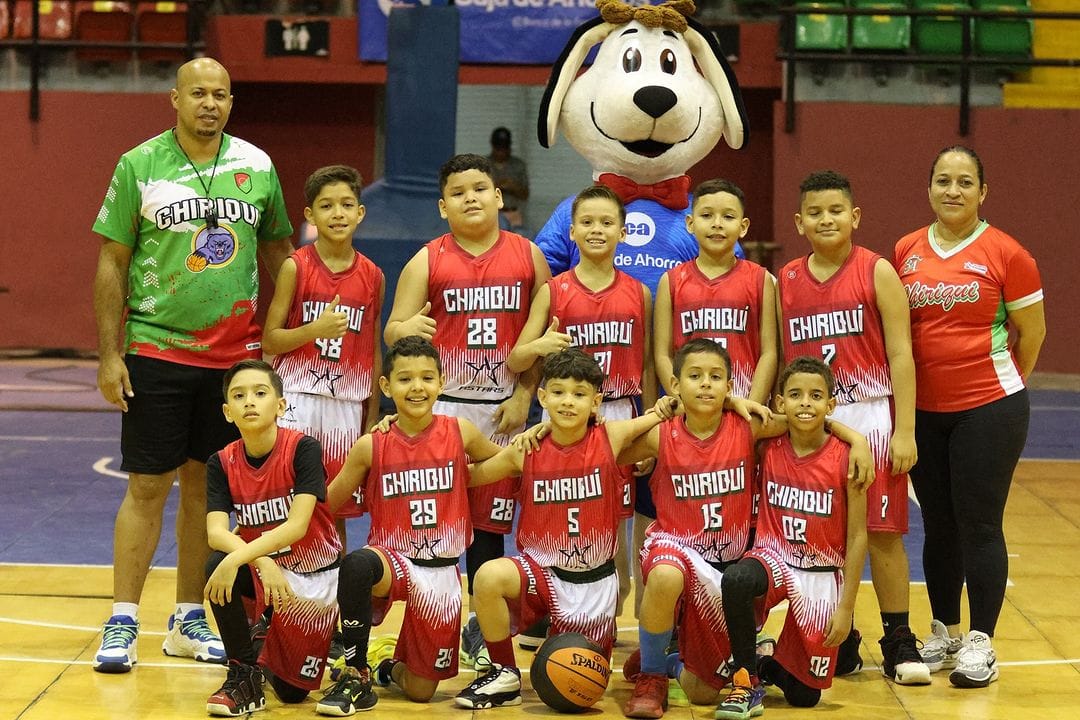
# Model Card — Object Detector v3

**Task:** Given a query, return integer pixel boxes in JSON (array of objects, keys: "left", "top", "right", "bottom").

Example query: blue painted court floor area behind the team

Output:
[{"left": 0, "top": 391, "right": 1080, "bottom": 581}]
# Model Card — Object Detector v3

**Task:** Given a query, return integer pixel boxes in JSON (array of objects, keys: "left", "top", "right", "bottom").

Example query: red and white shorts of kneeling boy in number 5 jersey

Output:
[{"left": 507, "top": 555, "right": 619, "bottom": 657}]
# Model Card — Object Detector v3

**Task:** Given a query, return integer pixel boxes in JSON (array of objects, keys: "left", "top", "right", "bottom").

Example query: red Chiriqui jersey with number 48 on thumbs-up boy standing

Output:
[{"left": 274, "top": 245, "right": 382, "bottom": 403}]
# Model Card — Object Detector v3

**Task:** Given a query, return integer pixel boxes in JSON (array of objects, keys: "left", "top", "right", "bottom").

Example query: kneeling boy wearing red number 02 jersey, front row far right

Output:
[{"left": 715, "top": 357, "right": 866, "bottom": 720}]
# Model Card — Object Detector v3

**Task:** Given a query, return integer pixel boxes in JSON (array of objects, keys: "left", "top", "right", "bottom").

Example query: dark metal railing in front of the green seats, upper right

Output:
[{"left": 777, "top": 5, "right": 1080, "bottom": 135}]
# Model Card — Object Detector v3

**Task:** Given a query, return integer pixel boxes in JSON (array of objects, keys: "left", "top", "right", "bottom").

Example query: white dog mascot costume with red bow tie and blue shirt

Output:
[{"left": 536, "top": 0, "right": 746, "bottom": 294}]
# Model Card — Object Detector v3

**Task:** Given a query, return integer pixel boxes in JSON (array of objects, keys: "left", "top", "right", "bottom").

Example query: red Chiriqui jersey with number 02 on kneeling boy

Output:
[{"left": 754, "top": 435, "right": 850, "bottom": 570}]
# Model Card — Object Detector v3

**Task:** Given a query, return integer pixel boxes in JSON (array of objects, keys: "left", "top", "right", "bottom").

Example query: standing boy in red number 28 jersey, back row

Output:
[{"left": 384, "top": 154, "right": 551, "bottom": 661}]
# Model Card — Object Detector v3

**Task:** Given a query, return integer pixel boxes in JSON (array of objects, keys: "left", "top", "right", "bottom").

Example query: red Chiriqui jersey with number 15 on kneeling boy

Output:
[{"left": 648, "top": 412, "right": 755, "bottom": 562}]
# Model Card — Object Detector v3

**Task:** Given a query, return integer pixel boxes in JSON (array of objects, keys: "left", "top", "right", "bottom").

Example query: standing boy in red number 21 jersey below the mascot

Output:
[{"left": 507, "top": 185, "right": 657, "bottom": 608}]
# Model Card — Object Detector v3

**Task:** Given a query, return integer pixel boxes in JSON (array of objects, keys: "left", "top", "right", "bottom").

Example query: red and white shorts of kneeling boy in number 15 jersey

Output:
[{"left": 642, "top": 536, "right": 731, "bottom": 690}]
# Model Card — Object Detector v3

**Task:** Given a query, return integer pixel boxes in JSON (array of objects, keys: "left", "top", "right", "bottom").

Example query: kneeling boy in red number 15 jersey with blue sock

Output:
[{"left": 623, "top": 338, "right": 874, "bottom": 718}]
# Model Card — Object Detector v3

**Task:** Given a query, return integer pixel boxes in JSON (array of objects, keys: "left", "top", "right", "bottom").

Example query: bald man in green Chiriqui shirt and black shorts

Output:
[{"left": 93, "top": 57, "right": 293, "bottom": 673}]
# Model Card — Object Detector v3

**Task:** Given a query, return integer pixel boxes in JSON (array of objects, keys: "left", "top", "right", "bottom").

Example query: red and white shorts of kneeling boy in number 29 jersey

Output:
[{"left": 369, "top": 546, "right": 461, "bottom": 682}]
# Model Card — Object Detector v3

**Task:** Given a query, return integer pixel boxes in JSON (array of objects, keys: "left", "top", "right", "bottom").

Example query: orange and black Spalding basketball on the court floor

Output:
[{"left": 529, "top": 633, "right": 611, "bottom": 712}]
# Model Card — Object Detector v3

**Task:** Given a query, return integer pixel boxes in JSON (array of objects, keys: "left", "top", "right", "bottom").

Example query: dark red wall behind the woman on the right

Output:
[{"left": 772, "top": 103, "right": 1080, "bottom": 373}]
